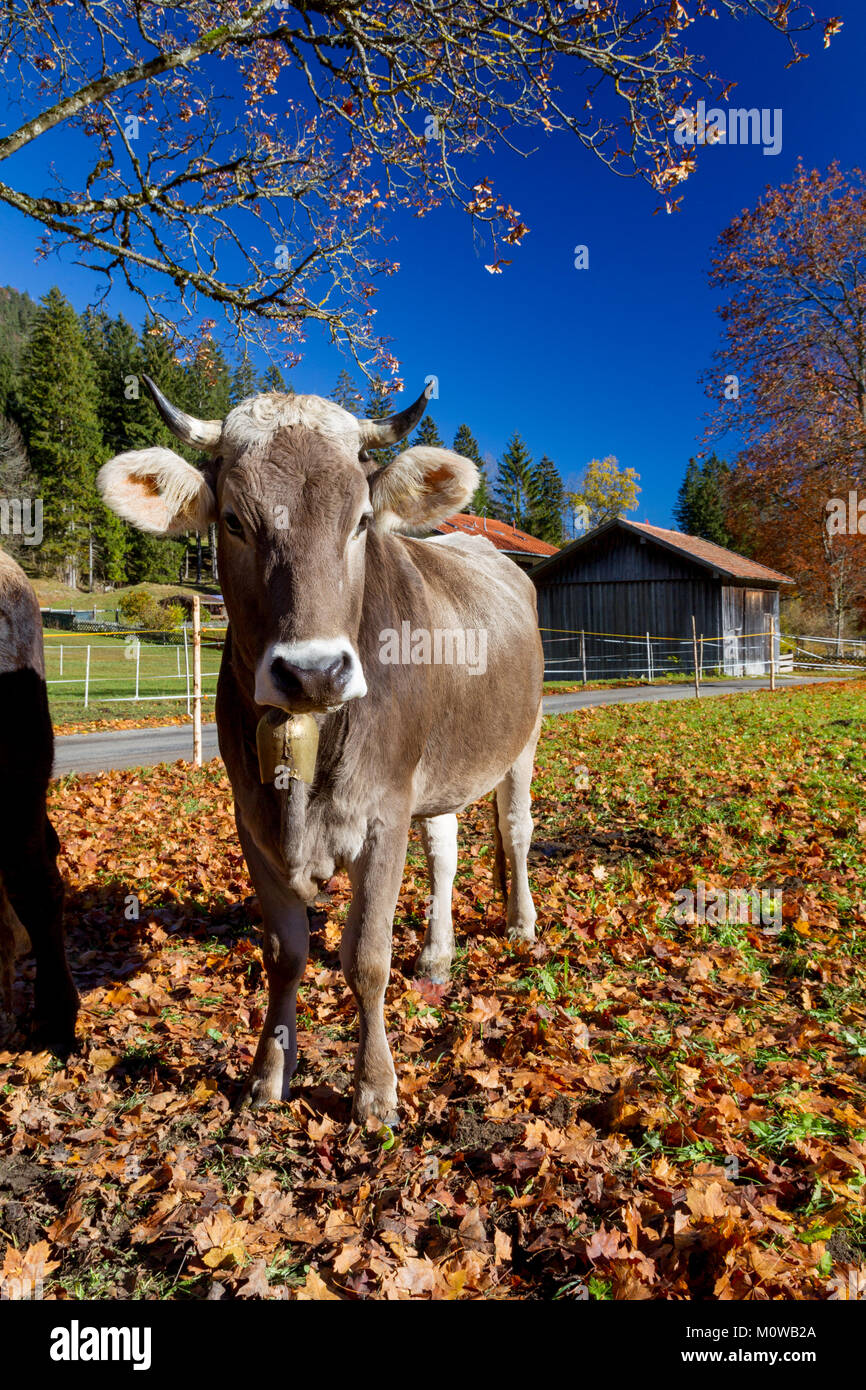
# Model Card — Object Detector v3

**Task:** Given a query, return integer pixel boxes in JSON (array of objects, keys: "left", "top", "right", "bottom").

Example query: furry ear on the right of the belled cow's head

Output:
[{"left": 370, "top": 445, "right": 478, "bottom": 531}]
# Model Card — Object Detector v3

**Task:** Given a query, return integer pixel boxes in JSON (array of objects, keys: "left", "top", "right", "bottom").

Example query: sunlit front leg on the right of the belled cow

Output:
[{"left": 339, "top": 817, "right": 409, "bottom": 1125}]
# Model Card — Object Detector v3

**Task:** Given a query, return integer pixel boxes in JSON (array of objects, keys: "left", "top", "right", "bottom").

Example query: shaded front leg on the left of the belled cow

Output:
[{"left": 240, "top": 831, "right": 310, "bottom": 1105}]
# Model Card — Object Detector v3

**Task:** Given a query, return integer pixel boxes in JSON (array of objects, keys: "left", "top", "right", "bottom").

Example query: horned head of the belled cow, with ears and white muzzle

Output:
[{"left": 99, "top": 377, "right": 477, "bottom": 710}]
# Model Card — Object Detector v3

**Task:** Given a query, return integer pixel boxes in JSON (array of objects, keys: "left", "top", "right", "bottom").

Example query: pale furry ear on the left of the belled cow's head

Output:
[{"left": 96, "top": 449, "right": 217, "bottom": 535}]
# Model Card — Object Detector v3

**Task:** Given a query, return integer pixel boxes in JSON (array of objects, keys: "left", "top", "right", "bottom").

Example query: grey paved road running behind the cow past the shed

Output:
[{"left": 54, "top": 676, "right": 845, "bottom": 777}]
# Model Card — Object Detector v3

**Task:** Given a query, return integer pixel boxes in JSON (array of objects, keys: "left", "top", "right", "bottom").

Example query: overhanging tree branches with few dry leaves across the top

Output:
[{"left": 0, "top": 0, "right": 840, "bottom": 370}]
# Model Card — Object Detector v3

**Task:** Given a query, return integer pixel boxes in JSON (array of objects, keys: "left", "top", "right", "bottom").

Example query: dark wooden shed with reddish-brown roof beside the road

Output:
[{"left": 531, "top": 517, "right": 794, "bottom": 680}]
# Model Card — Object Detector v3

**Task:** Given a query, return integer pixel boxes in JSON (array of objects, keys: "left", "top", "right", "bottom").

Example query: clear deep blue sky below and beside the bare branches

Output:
[{"left": 0, "top": 0, "right": 866, "bottom": 525}]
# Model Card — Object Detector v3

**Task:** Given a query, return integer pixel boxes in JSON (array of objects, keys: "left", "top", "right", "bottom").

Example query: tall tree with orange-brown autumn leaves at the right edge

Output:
[{"left": 705, "top": 164, "right": 866, "bottom": 637}]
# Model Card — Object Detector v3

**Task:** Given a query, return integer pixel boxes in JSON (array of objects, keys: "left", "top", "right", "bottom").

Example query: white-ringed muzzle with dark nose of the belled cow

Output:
[{"left": 256, "top": 638, "right": 367, "bottom": 710}]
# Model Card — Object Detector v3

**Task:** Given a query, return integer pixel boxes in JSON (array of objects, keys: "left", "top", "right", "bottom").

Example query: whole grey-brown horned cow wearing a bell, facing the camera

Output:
[{"left": 99, "top": 382, "right": 544, "bottom": 1123}]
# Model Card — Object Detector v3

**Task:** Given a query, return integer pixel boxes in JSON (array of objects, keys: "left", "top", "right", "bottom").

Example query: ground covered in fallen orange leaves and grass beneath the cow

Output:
[{"left": 0, "top": 684, "right": 866, "bottom": 1300}]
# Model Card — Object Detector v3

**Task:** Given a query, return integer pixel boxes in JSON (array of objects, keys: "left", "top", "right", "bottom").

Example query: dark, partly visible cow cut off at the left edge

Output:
[{"left": 0, "top": 550, "right": 78, "bottom": 1051}]
